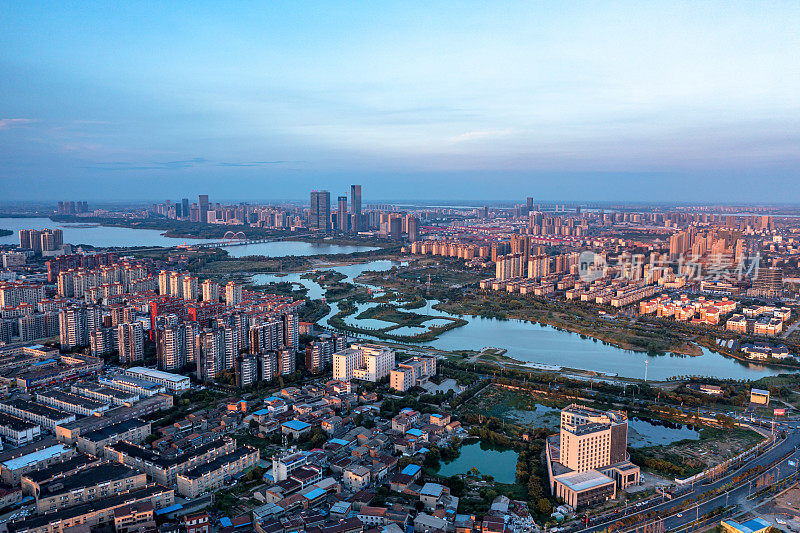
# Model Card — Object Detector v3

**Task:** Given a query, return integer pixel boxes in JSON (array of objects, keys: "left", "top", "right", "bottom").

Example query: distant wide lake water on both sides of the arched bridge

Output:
[{"left": 0, "top": 218, "right": 377, "bottom": 257}]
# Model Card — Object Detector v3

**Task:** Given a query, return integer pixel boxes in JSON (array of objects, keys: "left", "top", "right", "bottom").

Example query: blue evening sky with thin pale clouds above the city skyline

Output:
[{"left": 0, "top": 1, "right": 800, "bottom": 202}]
